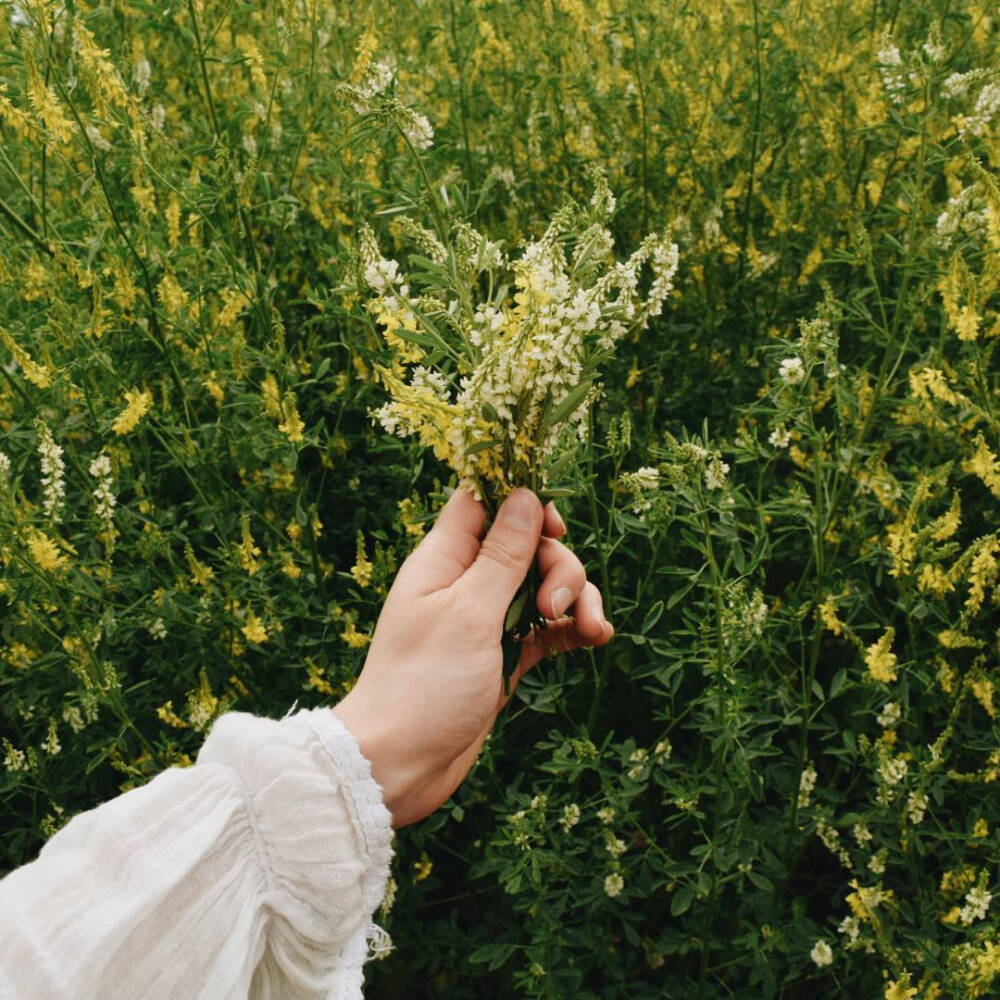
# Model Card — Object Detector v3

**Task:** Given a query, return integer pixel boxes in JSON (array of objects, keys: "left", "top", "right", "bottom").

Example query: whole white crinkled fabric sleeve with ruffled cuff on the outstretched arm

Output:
[{"left": 0, "top": 708, "right": 392, "bottom": 1000}]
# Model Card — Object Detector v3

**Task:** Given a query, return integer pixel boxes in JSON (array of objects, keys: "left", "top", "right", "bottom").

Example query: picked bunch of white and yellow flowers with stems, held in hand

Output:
[{"left": 360, "top": 174, "right": 677, "bottom": 685}]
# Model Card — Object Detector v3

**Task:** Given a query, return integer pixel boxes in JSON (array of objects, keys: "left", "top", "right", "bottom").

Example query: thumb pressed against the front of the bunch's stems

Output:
[{"left": 462, "top": 488, "right": 544, "bottom": 618}]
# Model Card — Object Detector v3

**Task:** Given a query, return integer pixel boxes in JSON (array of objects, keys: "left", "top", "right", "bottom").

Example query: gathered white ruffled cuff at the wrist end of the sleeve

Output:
[{"left": 198, "top": 708, "right": 392, "bottom": 1000}]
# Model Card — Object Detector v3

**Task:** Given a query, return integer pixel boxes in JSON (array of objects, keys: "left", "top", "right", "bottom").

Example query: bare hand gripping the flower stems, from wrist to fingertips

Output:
[{"left": 333, "top": 489, "right": 614, "bottom": 827}]
